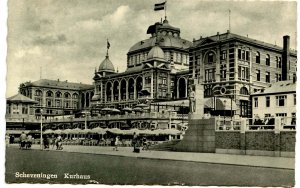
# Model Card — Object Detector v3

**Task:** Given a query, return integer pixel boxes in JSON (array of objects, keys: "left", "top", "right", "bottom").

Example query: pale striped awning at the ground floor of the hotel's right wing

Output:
[{"left": 204, "top": 97, "right": 237, "bottom": 110}]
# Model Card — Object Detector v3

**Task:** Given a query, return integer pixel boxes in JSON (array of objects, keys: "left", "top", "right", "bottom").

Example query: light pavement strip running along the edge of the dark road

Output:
[{"left": 9, "top": 144, "right": 295, "bottom": 170}]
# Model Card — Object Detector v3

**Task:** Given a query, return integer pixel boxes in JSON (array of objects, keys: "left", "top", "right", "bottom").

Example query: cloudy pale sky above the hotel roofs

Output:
[{"left": 6, "top": 0, "right": 297, "bottom": 97}]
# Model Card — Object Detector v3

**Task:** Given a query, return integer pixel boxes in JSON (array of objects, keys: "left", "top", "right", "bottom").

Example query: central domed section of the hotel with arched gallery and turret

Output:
[{"left": 93, "top": 20, "right": 192, "bottom": 109}]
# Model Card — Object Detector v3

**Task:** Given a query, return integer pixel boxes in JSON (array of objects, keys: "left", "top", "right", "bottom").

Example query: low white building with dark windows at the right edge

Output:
[{"left": 251, "top": 80, "right": 296, "bottom": 120}]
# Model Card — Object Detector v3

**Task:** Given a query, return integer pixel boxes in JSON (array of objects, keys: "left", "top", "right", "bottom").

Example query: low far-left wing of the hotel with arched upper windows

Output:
[{"left": 19, "top": 79, "right": 94, "bottom": 118}]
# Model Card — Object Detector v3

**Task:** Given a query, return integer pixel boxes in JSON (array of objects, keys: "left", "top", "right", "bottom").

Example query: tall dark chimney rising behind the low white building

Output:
[{"left": 281, "top": 35, "right": 290, "bottom": 81}]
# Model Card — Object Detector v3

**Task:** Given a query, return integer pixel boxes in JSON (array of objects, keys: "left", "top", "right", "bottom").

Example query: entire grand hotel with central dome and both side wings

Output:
[{"left": 8, "top": 17, "right": 297, "bottom": 125}]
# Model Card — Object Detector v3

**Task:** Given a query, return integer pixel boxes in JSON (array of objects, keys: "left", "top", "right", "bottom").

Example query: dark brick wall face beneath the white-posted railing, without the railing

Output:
[{"left": 215, "top": 130, "right": 296, "bottom": 157}]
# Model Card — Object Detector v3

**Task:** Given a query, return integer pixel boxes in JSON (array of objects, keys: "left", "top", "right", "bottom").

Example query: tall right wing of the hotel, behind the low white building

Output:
[{"left": 189, "top": 31, "right": 297, "bottom": 117}]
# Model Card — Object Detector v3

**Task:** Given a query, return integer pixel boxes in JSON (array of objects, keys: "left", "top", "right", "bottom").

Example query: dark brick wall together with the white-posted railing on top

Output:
[{"left": 215, "top": 117, "right": 296, "bottom": 157}]
